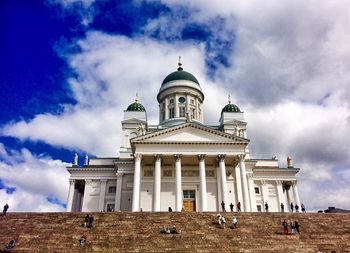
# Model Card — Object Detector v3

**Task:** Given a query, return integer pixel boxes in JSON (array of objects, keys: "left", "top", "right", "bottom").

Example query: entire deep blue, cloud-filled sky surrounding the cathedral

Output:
[{"left": 0, "top": 0, "right": 350, "bottom": 211}]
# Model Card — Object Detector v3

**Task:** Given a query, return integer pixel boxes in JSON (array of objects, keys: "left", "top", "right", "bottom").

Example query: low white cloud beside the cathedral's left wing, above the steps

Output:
[{"left": 0, "top": 143, "right": 69, "bottom": 212}]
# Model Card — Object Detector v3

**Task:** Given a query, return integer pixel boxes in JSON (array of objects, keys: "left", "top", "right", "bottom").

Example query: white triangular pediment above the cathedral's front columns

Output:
[{"left": 131, "top": 123, "right": 249, "bottom": 144}]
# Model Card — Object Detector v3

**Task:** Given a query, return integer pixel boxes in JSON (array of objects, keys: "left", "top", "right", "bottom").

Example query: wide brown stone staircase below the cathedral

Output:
[{"left": 0, "top": 212, "right": 350, "bottom": 253}]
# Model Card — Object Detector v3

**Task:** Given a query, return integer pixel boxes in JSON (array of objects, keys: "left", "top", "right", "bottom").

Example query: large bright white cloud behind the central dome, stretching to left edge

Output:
[{"left": 2, "top": 32, "right": 205, "bottom": 156}]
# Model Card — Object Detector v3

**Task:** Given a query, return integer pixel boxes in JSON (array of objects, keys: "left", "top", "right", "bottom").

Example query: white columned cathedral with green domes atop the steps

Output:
[{"left": 67, "top": 62, "right": 300, "bottom": 212}]
